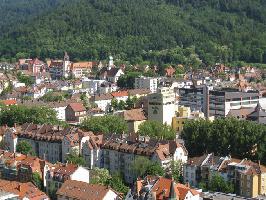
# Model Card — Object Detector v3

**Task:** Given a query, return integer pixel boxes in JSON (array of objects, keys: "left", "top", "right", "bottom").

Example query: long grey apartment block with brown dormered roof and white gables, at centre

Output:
[{"left": 102, "top": 139, "right": 187, "bottom": 183}]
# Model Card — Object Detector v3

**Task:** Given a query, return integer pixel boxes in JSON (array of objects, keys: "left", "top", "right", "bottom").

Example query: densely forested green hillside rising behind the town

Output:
[{"left": 0, "top": 0, "right": 266, "bottom": 65}]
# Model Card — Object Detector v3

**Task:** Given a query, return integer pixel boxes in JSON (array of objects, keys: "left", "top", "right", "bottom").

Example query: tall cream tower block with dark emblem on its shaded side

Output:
[{"left": 148, "top": 87, "right": 177, "bottom": 125}]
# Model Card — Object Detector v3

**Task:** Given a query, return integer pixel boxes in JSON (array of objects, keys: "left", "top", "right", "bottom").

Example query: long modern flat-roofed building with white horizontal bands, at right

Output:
[{"left": 207, "top": 89, "right": 260, "bottom": 117}]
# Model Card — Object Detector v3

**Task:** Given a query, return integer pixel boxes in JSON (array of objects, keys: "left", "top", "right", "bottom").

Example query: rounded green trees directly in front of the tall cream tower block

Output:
[{"left": 138, "top": 120, "right": 176, "bottom": 140}]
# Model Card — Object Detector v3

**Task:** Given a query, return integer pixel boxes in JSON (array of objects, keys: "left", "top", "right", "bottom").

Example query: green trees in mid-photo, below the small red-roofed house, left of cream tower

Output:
[{"left": 81, "top": 115, "right": 127, "bottom": 134}]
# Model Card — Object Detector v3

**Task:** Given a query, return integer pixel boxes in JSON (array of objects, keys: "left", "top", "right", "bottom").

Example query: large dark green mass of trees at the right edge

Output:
[{"left": 181, "top": 118, "right": 266, "bottom": 164}]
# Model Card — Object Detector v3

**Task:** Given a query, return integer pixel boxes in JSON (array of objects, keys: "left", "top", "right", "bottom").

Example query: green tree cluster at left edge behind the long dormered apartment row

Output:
[{"left": 0, "top": 105, "right": 61, "bottom": 126}]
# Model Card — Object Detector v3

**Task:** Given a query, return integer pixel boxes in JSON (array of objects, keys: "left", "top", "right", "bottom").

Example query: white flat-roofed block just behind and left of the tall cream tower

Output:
[{"left": 134, "top": 77, "right": 158, "bottom": 93}]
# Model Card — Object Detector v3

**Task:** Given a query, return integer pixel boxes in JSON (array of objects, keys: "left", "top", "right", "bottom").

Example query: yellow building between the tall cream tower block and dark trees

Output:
[{"left": 172, "top": 106, "right": 204, "bottom": 133}]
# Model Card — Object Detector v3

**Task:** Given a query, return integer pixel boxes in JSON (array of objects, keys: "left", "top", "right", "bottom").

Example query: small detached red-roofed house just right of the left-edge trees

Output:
[{"left": 66, "top": 103, "right": 86, "bottom": 124}]
